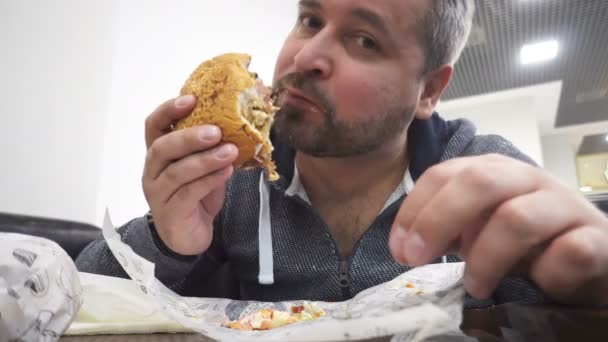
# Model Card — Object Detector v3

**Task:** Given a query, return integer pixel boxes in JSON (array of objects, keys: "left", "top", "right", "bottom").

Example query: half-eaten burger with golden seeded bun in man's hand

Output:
[{"left": 174, "top": 53, "right": 279, "bottom": 181}]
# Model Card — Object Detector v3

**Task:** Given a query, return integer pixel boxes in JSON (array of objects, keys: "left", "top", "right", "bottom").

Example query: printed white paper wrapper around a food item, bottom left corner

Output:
[{"left": 0, "top": 233, "right": 82, "bottom": 341}]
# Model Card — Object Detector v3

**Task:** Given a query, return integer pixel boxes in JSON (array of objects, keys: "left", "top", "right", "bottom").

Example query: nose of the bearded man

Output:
[{"left": 294, "top": 32, "right": 333, "bottom": 79}]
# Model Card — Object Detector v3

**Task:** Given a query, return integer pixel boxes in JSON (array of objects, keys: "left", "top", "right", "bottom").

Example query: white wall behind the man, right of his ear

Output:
[{"left": 438, "top": 81, "right": 608, "bottom": 188}]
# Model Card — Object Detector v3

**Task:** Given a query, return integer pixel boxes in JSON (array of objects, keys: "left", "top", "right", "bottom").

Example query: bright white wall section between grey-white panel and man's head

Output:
[{"left": 98, "top": 0, "right": 297, "bottom": 224}]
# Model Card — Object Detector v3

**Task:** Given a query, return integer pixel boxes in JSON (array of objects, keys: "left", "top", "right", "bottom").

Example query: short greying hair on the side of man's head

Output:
[{"left": 421, "top": 0, "right": 475, "bottom": 75}]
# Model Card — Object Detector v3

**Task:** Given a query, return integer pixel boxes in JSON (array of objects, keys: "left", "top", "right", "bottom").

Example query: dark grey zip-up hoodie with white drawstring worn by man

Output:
[{"left": 76, "top": 114, "right": 545, "bottom": 308}]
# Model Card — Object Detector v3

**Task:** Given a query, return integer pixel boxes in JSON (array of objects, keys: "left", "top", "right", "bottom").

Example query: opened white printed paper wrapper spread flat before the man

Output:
[{"left": 96, "top": 212, "right": 464, "bottom": 342}]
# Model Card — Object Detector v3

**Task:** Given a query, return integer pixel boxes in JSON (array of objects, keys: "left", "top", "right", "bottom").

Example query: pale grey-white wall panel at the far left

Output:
[{"left": 0, "top": 0, "right": 114, "bottom": 223}]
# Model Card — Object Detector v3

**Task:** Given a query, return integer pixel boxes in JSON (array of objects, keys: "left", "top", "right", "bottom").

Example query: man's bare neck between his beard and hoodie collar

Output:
[{"left": 296, "top": 131, "right": 408, "bottom": 202}]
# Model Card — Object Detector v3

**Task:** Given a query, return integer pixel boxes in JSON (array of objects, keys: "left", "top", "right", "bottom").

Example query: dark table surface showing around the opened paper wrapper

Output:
[{"left": 60, "top": 304, "right": 608, "bottom": 342}]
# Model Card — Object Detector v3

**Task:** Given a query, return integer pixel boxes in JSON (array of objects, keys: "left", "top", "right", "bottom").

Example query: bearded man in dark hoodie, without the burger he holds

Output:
[{"left": 77, "top": 0, "right": 608, "bottom": 306}]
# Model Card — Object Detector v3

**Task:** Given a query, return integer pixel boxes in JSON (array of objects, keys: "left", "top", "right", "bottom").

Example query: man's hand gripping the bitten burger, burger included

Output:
[{"left": 142, "top": 54, "right": 278, "bottom": 255}]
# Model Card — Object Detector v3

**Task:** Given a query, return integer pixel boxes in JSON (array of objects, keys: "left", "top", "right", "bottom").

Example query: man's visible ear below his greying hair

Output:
[{"left": 416, "top": 64, "right": 454, "bottom": 119}]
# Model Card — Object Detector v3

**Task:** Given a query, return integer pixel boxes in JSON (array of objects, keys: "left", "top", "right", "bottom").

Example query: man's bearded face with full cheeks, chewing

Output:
[{"left": 274, "top": 0, "right": 427, "bottom": 157}]
